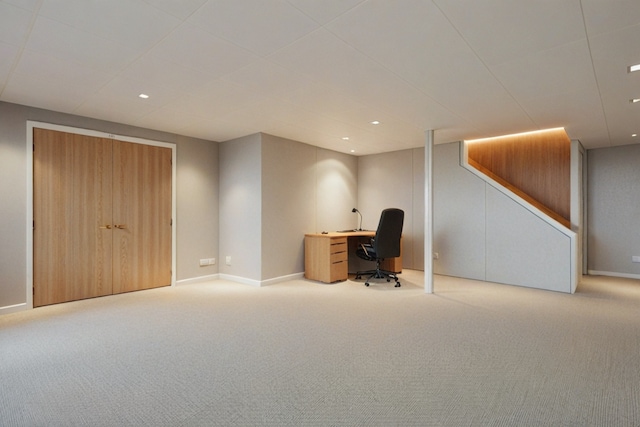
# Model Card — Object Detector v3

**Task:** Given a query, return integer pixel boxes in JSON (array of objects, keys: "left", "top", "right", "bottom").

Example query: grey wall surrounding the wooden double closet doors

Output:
[{"left": 0, "top": 102, "right": 218, "bottom": 312}]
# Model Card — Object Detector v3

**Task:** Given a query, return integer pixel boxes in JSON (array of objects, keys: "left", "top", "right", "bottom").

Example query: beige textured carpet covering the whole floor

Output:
[{"left": 0, "top": 270, "right": 640, "bottom": 427}]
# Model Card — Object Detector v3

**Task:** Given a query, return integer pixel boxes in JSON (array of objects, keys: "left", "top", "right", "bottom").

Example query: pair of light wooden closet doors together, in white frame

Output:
[{"left": 33, "top": 128, "right": 172, "bottom": 307}]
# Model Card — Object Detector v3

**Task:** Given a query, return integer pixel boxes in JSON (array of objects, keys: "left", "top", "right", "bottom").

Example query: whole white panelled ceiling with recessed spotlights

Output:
[{"left": 0, "top": 0, "right": 640, "bottom": 155}]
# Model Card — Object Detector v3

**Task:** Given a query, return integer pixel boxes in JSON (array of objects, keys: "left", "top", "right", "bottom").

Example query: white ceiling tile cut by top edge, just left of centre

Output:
[{"left": 189, "top": 0, "right": 318, "bottom": 55}]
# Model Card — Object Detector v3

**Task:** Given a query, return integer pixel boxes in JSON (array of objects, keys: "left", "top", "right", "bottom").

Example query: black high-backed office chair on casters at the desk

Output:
[{"left": 356, "top": 208, "right": 404, "bottom": 288}]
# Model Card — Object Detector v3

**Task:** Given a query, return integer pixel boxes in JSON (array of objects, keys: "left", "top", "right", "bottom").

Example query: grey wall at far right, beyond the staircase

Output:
[{"left": 587, "top": 145, "right": 640, "bottom": 278}]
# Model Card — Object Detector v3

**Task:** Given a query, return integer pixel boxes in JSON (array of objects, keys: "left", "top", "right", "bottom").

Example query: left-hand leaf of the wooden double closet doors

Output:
[{"left": 33, "top": 129, "right": 112, "bottom": 307}]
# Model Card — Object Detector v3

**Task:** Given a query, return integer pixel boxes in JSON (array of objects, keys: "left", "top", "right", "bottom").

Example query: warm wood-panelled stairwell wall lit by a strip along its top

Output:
[{"left": 467, "top": 129, "right": 571, "bottom": 227}]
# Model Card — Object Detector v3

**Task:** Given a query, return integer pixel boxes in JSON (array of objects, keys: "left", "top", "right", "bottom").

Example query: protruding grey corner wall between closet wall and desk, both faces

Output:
[{"left": 220, "top": 134, "right": 357, "bottom": 286}]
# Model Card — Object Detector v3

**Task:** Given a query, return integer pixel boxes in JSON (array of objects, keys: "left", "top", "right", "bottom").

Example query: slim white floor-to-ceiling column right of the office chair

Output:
[{"left": 424, "top": 129, "right": 433, "bottom": 294}]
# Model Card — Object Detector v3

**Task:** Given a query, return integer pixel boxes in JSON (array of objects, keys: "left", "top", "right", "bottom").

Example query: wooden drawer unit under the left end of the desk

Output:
[{"left": 304, "top": 235, "right": 349, "bottom": 283}]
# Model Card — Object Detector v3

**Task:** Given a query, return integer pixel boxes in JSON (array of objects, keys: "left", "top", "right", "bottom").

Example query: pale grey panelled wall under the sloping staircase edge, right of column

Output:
[{"left": 433, "top": 143, "right": 575, "bottom": 293}]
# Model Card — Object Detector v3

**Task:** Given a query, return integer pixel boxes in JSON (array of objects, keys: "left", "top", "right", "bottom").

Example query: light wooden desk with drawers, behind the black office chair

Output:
[{"left": 304, "top": 231, "right": 402, "bottom": 283}]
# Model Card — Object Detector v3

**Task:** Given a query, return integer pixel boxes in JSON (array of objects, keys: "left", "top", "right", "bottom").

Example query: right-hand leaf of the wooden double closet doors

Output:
[{"left": 113, "top": 141, "right": 171, "bottom": 293}]
